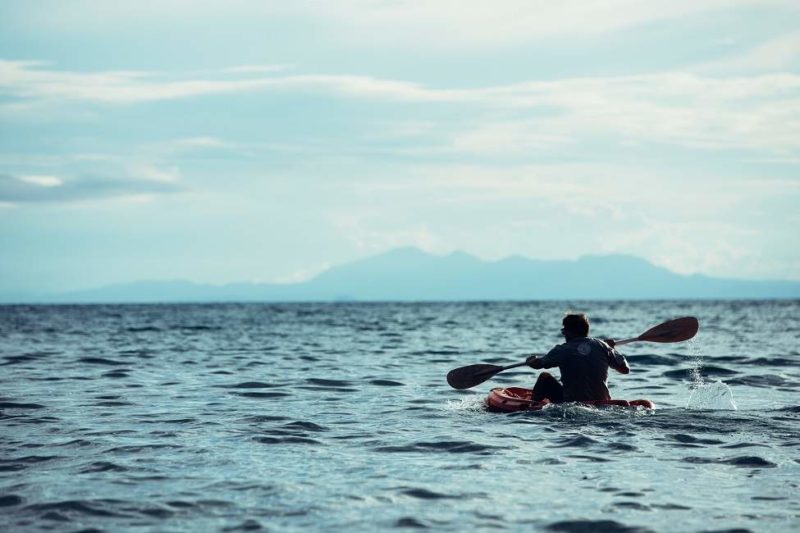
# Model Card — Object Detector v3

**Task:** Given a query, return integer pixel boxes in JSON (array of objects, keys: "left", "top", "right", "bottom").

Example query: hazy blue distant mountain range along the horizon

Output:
[{"left": 0, "top": 248, "right": 800, "bottom": 303}]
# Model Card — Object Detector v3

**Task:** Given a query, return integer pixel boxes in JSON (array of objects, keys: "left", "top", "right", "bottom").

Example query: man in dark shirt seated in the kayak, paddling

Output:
[{"left": 526, "top": 314, "right": 631, "bottom": 403}]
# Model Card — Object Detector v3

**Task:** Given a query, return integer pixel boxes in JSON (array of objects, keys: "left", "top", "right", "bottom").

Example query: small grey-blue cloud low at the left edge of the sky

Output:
[{"left": 0, "top": 174, "right": 185, "bottom": 204}]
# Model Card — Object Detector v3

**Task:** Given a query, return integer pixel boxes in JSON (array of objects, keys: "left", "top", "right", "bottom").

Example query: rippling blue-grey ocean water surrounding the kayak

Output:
[{"left": 0, "top": 301, "right": 800, "bottom": 532}]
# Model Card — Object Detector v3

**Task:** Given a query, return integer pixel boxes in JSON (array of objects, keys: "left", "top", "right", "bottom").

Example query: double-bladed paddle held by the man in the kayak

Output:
[{"left": 447, "top": 316, "right": 700, "bottom": 389}]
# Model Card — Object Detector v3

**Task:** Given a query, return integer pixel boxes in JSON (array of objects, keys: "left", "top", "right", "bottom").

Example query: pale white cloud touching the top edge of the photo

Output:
[{"left": 296, "top": 0, "right": 756, "bottom": 51}]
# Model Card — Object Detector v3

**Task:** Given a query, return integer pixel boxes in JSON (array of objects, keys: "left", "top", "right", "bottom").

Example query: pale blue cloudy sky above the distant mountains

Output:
[{"left": 0, "top": 0, "right": 800, "bottom": 292}]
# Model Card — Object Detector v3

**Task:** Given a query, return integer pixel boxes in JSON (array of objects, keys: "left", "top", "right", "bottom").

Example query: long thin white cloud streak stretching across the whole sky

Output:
[{"left": 0, "top": 60, "right": 800, "bottom": 109}]
